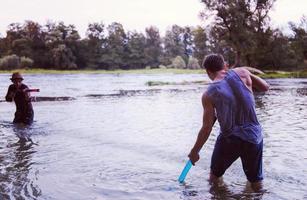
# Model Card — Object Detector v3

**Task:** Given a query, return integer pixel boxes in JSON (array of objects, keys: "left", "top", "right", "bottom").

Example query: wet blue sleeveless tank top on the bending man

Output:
[{"left": 207, "top": 70, "right": 263, "bottom": 144}]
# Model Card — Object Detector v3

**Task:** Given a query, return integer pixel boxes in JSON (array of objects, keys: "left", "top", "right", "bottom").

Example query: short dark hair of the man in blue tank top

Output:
[{"left": 202, "top": 54, "right": 225, "bottom": 72}]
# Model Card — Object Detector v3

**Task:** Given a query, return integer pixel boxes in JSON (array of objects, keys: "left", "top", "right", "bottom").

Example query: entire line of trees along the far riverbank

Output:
[{"left": 0, "top": 0, "right": 307, "bottom": 70}]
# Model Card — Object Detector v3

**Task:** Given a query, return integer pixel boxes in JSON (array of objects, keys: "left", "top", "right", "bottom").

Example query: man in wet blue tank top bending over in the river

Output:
[{"left": 189, "top": 54, "right": 269, "bottom": 190}]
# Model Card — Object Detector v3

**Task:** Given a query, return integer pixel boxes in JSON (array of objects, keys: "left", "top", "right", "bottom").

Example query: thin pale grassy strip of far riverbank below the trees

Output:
[{"left": 0, "top": 68, "right": 307, "bottom": 78}]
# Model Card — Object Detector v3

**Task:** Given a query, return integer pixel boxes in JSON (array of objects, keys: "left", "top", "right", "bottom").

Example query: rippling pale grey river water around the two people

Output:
[{"left": 0, "top": 74, "right": 307, "bottom": 200}]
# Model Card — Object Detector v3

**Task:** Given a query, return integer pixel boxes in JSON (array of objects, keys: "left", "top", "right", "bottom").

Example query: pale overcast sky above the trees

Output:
[{"left": 0, "top": 0, "right": 307, "bottom": 36}]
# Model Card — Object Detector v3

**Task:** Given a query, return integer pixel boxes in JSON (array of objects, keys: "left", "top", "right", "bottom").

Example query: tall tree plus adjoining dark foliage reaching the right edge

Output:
[{"left": 202, "top": 0, "right": 307, "bottom": 69}]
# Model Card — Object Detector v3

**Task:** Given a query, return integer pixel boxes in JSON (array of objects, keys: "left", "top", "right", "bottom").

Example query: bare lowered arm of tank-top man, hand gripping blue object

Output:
[{"left": 189, "top": 94, "right": 216, "bottom": 165}]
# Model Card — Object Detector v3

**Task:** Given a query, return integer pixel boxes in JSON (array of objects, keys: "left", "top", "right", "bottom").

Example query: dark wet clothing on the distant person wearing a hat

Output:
[{"left": 6, "top": 84, "right": 34, "bottom": 124}]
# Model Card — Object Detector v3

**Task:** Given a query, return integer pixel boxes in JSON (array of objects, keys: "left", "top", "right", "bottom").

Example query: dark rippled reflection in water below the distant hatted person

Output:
[{"left": 0, "top": 125, "right": 41, "bottom": 199}]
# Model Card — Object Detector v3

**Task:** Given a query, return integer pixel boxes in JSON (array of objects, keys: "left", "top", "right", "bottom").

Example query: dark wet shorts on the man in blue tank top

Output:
[{"left": 211, "top": 136, "right": 263, "bottom": 182}]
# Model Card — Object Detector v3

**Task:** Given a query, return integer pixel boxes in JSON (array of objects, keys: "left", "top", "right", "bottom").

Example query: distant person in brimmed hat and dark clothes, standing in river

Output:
[{"left": 5, "top": 72, "right": 34, "bottom": 125}]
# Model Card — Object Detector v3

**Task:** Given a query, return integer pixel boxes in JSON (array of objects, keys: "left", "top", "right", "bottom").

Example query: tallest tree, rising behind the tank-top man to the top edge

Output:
[{"left": 202, "top": 0, "right": 275, "bottom": 66}]
